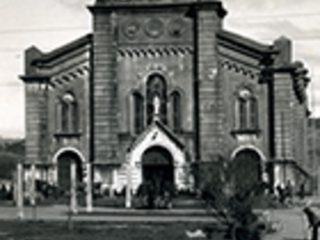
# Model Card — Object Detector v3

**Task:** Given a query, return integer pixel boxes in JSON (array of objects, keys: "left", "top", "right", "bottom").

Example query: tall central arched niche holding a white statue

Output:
[{"left": 147, "top": 74, "right": 167, "bottom": 124}]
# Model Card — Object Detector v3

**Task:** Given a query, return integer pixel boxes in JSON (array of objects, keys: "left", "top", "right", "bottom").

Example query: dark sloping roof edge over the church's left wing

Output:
[{"left": 32, "top": 34, "right": 92, "bottom": 65}]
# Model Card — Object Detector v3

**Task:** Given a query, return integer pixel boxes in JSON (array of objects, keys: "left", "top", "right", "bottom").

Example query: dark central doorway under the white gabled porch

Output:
[{"left": 142, "top": 146, "right": 174, "bottom": 192}]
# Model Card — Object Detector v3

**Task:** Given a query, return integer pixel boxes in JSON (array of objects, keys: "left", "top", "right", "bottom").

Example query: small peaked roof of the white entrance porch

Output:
[{"left": 130, "top": 120, "right": 184, "bottom": 151}]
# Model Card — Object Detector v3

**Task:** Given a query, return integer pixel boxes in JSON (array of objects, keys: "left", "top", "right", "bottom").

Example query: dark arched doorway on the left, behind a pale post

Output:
[{"left": 57, "top": 151, "right": 83, "bottom": 190}]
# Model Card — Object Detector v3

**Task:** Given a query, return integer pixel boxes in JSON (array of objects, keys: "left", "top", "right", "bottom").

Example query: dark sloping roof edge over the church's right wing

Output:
[{"left": 217, "top": 30, "right": 278, "bottom": 58}]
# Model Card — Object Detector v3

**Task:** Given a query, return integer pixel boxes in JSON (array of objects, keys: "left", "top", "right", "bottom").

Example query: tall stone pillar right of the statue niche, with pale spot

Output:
[{"left": 195, "top": 5, "right": 225, "bottom": 161}]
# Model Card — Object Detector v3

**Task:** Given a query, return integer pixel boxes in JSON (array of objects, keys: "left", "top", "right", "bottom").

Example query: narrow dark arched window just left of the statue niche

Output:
[{"left": 133, "top": 92, "right": 144, "bottom": 134}]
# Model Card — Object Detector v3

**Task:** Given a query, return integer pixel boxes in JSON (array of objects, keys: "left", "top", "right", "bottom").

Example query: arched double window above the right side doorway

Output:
[{"left": 237, "top": 89, "right": 258, "bottom": 130}]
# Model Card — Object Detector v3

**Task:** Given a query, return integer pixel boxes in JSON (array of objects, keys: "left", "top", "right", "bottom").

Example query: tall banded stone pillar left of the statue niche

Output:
[{"left": 92, "top": 7, "right": 119, "bottom": 165}]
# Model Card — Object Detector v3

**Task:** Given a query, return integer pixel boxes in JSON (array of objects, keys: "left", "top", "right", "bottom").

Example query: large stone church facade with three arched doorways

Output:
[{"left": 21, "top": 0, "right": 310, "bottom": 195}]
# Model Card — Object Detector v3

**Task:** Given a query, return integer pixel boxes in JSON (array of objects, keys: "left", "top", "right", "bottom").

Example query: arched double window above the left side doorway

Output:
[{"left": 57, "top": 93, "right": 79, "bottom": 133}]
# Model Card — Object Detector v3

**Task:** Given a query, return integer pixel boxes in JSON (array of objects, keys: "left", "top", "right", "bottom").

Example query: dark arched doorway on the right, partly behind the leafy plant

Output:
[{"left": 231, "top": 149, "right": 262, "bottom": 192}]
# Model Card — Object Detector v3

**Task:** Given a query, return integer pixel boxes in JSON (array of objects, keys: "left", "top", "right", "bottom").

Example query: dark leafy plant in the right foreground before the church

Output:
[{"left": 199, "top": 156, "right": 265, "bottom": 240}]
